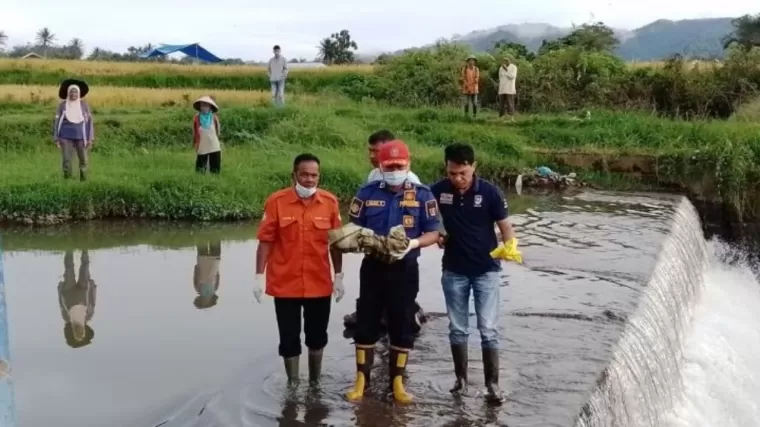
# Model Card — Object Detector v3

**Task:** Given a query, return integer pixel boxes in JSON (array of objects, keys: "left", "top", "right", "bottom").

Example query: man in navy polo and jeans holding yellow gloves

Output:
[{"left": 430, "top": 143, "right": 517, "bottom": 403}]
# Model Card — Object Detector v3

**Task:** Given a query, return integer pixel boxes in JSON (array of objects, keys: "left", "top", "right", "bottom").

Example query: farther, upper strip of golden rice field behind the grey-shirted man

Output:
[{"left": 0, "top": 58, "right": 374, "bottom": 76}]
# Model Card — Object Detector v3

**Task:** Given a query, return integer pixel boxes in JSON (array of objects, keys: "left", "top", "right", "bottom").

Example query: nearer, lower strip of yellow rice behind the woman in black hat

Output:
[{"left": 0, "top": 85, "right": 317, "bottom": 107}]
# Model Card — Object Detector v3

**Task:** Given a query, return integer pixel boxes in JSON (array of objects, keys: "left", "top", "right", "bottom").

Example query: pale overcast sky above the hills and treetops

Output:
[{"left": 0, "top": 0, "right": 760, "bottom": 60}]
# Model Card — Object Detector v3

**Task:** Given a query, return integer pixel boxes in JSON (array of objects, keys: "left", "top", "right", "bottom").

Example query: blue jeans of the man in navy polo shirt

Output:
[{"left": 441, "top": 270, "right": 501, "bottom": 348}]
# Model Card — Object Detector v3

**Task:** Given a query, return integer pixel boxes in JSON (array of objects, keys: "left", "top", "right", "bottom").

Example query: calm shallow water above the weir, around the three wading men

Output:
[{"left": 4, "top": 193, "right": 674, "bottom": 427}]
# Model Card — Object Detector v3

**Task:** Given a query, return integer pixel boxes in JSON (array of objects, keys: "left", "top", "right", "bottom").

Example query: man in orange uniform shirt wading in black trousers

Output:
[{"left": 253, "top": 154, "right": 344, "bottom": 385}]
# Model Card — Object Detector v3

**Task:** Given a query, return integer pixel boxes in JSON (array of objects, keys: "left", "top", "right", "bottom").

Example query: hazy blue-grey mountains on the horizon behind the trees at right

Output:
[{"left": 398, "top": 18, "right": 733, "bottom": 61}]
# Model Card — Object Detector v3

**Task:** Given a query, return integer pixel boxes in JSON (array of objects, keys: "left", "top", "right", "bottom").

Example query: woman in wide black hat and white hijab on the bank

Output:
[{"left": 53, "top": 79, "right": 95, "bottom": 181}]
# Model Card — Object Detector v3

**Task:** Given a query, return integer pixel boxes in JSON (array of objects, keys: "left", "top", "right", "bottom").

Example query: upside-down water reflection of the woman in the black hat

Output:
[{"left": 58, "top": 250, "right": 97, "bottom": 348}]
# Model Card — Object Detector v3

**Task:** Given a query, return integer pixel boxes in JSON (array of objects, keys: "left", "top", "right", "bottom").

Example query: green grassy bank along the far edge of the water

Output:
[{"left": 0, "top": 99, "right": 760, "bottom": 222}]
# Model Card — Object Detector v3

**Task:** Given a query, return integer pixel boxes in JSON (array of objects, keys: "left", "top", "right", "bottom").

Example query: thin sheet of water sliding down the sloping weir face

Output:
[{"left": 575, "top": 198, "right": 708, "bottom": 427}]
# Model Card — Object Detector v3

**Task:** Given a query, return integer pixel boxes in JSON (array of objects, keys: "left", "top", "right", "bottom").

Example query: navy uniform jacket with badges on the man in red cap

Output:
[{"left": 348, "top": 181, "right": 441, "bottom": 259}]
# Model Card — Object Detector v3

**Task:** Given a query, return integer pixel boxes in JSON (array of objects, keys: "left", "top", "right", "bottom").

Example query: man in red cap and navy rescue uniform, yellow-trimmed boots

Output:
[{"left": 346, "top": 140, "right": 440, "bottom": 403}]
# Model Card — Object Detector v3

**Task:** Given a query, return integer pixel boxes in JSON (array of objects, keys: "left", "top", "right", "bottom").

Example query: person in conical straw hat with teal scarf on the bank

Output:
[{"left": 193, "top": 95, "right": 222, "bottom": 174}]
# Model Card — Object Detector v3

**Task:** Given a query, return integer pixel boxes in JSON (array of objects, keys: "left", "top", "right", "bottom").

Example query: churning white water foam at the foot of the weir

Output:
[{"left": 666, "top": 242, "right": 760, "bottom": 427}]
